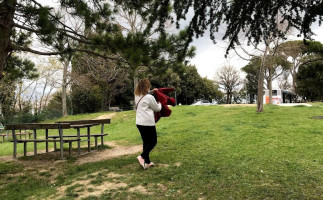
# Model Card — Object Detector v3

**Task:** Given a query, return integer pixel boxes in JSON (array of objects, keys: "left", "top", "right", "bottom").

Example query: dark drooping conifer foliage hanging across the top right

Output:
[{"left": 120, "top": 0, "right": 323, "bottom": 53}]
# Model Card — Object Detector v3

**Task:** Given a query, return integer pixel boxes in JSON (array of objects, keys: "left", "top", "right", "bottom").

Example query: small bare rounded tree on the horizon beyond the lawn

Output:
[{"left": 215, "top": 66, "right": 242, "bottom": 104}]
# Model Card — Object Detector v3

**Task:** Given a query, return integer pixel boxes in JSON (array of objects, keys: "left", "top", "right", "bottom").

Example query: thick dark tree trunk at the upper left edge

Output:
[{"left": 0, "top": 0, "right": 17, "bottom": 81}]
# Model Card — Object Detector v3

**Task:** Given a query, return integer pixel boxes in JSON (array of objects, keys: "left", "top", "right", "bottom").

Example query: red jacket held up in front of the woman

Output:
[{"left": 155, "top": 88, "right": 175, "bottom": 122}]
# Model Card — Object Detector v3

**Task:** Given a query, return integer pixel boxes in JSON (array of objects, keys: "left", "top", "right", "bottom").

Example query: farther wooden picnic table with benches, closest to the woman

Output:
[{"left": 55, "top": 119, "right": 111, "bottom": 154}]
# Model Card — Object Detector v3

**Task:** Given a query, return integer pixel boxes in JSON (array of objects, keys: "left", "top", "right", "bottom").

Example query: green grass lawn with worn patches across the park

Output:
[{"left": 0, "top": 103, "right": 323, "bottom": 200}]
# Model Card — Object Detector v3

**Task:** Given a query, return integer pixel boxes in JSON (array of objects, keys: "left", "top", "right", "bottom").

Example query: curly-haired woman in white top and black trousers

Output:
[{"left": 135, "top": 79, "right": 161, "bottom": 169}]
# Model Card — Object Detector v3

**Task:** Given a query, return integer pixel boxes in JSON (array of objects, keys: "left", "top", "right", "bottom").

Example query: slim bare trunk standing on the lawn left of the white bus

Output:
[{"left": 257, "top": 44, "right": 269, "bottom": 112}]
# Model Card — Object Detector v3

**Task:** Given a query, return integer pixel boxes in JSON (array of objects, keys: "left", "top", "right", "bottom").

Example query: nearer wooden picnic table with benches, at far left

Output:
[{"left": 5, "top": 123, "right": 80, "bottom": 159}]
